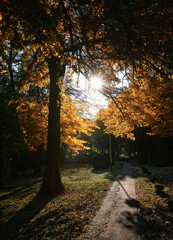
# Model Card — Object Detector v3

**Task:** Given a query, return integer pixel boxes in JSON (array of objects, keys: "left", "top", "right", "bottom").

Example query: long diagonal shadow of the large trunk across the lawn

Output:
[{"left": 0, "top": 190, "right": 53, "bottom": 240}]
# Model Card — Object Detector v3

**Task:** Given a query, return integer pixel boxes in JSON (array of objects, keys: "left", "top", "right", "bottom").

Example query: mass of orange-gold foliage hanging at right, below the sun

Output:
[{"left": 98, "top": 62, "right": 173, "bottom": 140}]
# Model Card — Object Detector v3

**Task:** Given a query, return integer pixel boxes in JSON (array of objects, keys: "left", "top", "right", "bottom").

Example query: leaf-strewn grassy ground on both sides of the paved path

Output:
[{"left": 0, "top": 164, "right": 173, "bottom": 240}]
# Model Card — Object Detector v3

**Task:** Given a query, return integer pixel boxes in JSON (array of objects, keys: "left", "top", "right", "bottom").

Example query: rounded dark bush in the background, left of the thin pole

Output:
[{"left": 92, "top": 153, "right": 110, "bottom": 170}]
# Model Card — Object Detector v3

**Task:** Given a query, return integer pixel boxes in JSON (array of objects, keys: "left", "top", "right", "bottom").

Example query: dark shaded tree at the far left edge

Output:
[{"left": 0, "top": 41, "right": 24, "bottom": 187}]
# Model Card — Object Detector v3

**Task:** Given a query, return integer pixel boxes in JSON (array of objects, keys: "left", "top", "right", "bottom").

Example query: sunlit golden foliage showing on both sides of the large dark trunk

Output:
[{"left": 16, "top": 89, "right": 95, "bottom": 152}]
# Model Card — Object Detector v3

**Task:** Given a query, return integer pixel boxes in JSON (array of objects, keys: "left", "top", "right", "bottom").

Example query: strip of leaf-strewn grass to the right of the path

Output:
[{"left": 136, "top": 169, "right": 173, "bottom": 240}]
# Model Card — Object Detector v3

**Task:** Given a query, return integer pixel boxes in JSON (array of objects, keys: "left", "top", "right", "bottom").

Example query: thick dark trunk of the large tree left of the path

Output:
[{"left": 41, "top": 57, "right": 65, "bottom": 195}]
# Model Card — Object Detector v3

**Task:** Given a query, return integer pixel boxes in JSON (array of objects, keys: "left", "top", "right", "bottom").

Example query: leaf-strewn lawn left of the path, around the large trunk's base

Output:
[{"left": 0, "top": 165, "right": 121, "bottom": 240}]
